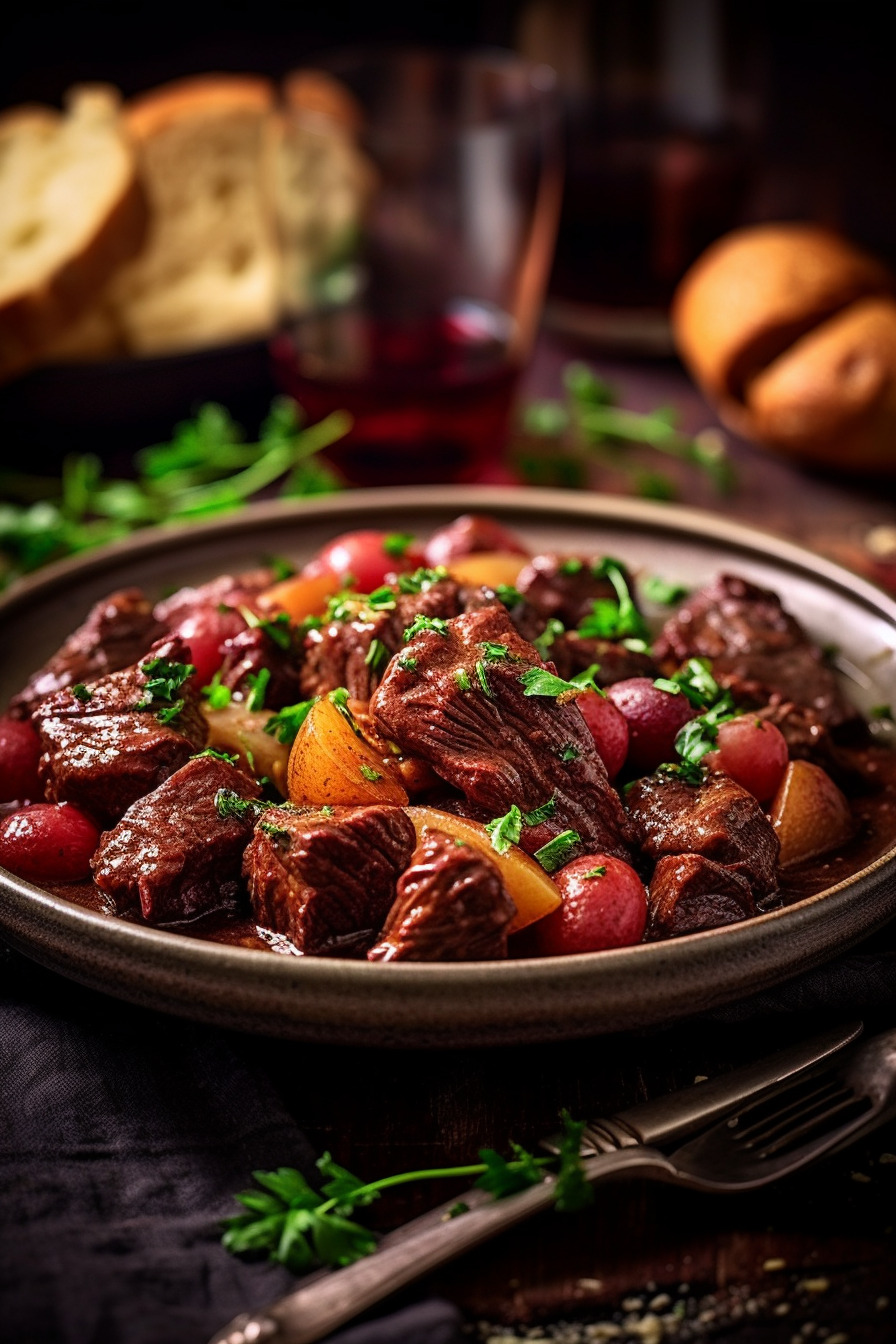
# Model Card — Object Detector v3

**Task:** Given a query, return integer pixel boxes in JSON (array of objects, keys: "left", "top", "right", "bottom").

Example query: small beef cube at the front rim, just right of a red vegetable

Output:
[{"left": 647, "top": 853, "right": 756, "bottom": 939}]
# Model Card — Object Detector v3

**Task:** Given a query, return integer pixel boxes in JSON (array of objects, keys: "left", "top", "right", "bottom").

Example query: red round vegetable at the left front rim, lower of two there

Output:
[{"left": 0, "top": 802, "right": 99, "bottom": 882}]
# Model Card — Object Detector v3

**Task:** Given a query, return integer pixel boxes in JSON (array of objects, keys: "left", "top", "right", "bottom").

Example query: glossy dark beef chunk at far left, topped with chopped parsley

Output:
[{"left": 32, "top": 638, "right": 207, "bottom": 827}]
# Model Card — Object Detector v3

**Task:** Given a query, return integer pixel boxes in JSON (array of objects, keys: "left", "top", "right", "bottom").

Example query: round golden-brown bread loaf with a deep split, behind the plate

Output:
[{"left": 672, "top": 223, "right": 896, "bottom": 472}]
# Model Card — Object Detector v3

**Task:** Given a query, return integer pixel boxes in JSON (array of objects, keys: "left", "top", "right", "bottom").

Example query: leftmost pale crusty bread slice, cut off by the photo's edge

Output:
[{"left": 0, "top": 85, "right": 146, "bottom": 378}]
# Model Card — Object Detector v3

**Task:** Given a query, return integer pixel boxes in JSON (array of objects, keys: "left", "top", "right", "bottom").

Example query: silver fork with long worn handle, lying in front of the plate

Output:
[{"left": 210, "top": 1031, "right": 896, "bottom": 1344}]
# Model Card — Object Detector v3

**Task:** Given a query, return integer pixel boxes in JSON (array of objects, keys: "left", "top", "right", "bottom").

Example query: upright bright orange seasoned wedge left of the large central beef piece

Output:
[{"left": 287, "top": 698, "right": 407, "bottom": 808}]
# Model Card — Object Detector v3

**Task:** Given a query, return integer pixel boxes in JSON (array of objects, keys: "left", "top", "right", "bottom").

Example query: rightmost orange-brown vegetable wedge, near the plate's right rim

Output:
[{"left": 771, "top": 761, "right": 856, "bottom": 868}]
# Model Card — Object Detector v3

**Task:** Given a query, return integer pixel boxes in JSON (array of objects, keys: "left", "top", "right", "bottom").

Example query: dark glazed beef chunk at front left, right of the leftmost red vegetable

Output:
[{"left": 91, "top": 757, "right": 261, "bottom": 923}]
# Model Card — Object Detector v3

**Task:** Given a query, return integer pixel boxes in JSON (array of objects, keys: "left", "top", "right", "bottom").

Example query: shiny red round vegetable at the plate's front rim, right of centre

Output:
[{"left": 533, "top": 853, "right": 647, "bottom": 957}]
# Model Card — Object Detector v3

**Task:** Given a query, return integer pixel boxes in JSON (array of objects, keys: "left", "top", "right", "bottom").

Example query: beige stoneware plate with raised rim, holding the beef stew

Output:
[{"left": 0, "top": 487, "right": 896, "bottom": 1046}]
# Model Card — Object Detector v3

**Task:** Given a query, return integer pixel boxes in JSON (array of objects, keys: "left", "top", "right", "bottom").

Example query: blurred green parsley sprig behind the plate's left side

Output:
[{"left": 0, "top": 396, "right": 351, "bottom": 587}]
